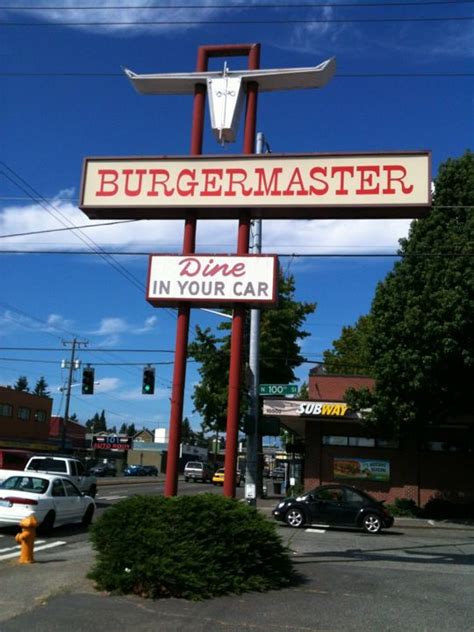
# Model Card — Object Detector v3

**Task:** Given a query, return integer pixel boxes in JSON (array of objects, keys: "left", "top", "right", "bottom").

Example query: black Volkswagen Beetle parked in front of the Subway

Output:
[{"left": 272, "top": 485, "right": 393, "bottom": 533}]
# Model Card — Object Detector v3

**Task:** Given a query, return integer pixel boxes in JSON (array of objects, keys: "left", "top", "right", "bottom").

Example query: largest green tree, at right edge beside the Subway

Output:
[{"left": 347, "top": 151, "right": 474, "bottom": 430}]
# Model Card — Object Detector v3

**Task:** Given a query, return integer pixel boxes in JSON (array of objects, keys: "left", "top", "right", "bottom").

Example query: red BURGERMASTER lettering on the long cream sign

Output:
[{"left": 95, "top": 164, "right": 414, "bottom": 199}]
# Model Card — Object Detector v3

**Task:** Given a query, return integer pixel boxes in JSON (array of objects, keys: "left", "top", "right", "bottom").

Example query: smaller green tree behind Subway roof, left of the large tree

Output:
[{"left": 323, "top": 314, "right": 373, "bottom": 376}]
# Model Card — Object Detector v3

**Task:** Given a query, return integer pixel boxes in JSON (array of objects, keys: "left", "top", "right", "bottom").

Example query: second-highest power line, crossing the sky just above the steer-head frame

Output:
[{"left": 0, "top": 16, "right": 474, "bottom": 27}]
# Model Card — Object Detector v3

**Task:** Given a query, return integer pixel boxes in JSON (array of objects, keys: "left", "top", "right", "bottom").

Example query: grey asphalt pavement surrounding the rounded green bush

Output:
[{"left": 0, "top": 480, "right": 474, "bottom": 632}]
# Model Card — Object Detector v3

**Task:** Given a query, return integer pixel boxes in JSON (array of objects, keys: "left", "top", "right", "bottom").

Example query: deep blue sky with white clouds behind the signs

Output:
[{"left": 0, "top": 0, "right": 474, "bottom": 429}]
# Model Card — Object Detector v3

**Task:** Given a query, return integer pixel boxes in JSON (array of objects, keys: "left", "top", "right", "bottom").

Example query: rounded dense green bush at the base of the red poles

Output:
[{"left": 89, "top": 494, "right": 295, "bottom": 599}]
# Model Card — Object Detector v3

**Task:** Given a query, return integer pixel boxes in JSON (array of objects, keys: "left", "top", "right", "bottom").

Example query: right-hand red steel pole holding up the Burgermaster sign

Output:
[{"left": 224, "top": 44, "right": 260, "bottom": 498}]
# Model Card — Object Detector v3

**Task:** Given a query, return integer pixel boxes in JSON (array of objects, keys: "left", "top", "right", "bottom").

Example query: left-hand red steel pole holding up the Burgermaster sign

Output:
[{"left": 164, "top": 54, "right": 207, "bottom": 496}]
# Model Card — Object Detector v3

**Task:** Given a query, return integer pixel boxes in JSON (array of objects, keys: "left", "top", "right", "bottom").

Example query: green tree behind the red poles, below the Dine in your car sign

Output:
[{"left": 188, "top": 275, "right": 316, "bottom": 432}]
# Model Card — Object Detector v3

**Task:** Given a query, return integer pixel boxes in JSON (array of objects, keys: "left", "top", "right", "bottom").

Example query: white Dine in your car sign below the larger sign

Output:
[{"left": 147, "top": 254, "right": 278, "bottom": 307}]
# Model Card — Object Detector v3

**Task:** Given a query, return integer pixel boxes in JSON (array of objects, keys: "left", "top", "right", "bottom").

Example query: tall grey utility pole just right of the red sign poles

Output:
[{"left": 245, "top": 132, "right": 268, "bottom": 506}]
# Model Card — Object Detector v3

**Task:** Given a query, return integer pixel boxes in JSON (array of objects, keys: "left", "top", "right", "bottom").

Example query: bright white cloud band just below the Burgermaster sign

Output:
[{"left": 0, "top": 199, "right": 409, "bottom": 256}]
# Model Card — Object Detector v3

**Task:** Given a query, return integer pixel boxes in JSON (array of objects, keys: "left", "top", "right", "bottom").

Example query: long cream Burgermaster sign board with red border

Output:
[{"left": 80, "top": 152, "right": 431, "bottom": 219}]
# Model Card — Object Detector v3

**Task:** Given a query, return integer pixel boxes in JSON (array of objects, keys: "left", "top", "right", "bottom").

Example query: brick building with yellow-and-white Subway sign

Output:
[{"left": 264, "top": 371, "right": 474, "bottom": 506}]
